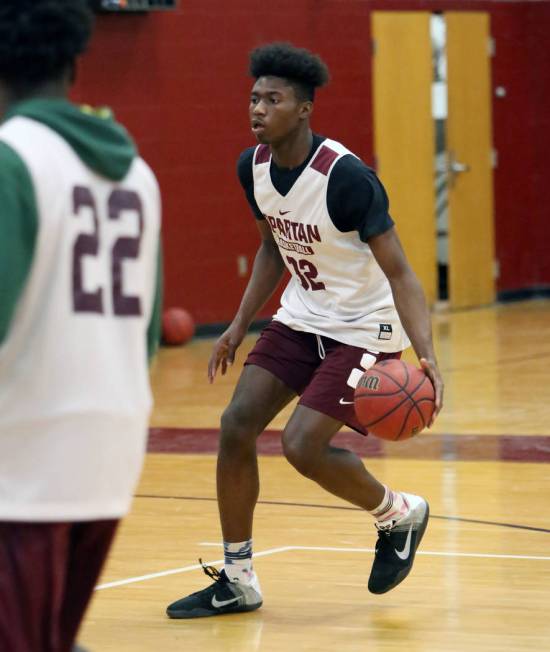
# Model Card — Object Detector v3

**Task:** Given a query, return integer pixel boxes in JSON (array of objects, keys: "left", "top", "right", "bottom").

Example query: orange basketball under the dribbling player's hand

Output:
[{"left": 355, "top": 359, "right": 435, "bottom": 441}]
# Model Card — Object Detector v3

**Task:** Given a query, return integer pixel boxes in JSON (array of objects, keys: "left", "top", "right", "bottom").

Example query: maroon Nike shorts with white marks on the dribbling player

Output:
[{"left": 245, "top": 321, "right": 401, "bottom": 435}]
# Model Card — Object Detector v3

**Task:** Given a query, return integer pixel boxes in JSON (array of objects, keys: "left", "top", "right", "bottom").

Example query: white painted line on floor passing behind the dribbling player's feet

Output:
[{"left": 95, "top": 541, "right": 550, "bottom": 591}]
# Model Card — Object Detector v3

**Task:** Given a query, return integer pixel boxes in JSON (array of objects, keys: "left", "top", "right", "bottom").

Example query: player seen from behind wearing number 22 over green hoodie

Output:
[{"left": 0, "top": 0, "right": 160, "bottom": 652}]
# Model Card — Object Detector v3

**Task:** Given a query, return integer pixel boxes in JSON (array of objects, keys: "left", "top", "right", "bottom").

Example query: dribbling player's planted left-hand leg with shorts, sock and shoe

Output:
[{"left": 167, "top": 322, "right": 320, "bottom": 618}]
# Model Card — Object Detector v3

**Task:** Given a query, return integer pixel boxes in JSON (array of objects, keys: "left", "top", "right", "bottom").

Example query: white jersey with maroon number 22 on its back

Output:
[{"left": 0, "top": 117, "right": 160, "bottom": 521}]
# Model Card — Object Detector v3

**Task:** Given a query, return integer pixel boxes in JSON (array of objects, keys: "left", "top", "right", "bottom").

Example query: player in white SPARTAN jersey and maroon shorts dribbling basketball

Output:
[{"left": 167, "top": 43, "right": 443, "bottom": 618}]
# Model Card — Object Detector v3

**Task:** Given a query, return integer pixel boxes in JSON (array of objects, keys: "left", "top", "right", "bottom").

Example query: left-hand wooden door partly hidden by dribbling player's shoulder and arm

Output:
[{"left": 372, "top": 11, "right": 436, "bottom": 304}]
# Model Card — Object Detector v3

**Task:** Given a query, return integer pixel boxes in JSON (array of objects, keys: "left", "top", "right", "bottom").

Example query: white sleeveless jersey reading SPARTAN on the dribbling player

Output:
[{"left": 253, "top": 140, "right": 409, "bottom": 352}]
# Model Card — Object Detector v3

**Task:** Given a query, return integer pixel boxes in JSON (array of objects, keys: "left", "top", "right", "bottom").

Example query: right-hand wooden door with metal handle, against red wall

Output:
[{"left": 445, "top": 12, "right": 495, "bottom": 308}]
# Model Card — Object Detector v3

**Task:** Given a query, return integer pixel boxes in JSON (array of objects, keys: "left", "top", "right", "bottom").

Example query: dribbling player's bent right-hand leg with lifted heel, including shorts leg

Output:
[{"left": 284, "top": 338, "right": 429, "bottom": 593}]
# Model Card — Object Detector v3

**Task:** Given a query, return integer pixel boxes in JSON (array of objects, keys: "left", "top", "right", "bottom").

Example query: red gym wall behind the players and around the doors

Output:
[{"left": 74, "top": 0, "right": 550, "bottom": 324}]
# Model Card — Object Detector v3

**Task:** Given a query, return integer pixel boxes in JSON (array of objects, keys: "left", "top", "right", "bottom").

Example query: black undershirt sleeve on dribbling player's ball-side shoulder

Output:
[{"left": 327, "top": 154, "right": 394, "bottom": 242}]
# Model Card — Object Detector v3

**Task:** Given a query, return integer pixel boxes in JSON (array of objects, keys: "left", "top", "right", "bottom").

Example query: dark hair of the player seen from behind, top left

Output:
[{"left": 0, "top": 0, "right": 93, "bottom": 93}]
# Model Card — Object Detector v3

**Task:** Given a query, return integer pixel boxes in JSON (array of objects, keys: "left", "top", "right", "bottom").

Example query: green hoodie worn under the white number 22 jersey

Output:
[{"left": 0, "top": 99, "right": 162, "bottom": 356}]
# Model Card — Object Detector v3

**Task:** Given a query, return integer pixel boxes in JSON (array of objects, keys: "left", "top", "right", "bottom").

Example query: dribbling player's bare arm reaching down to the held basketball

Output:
[{"left": 368, "top": 227, "right": 443, "bottom": 426}]
